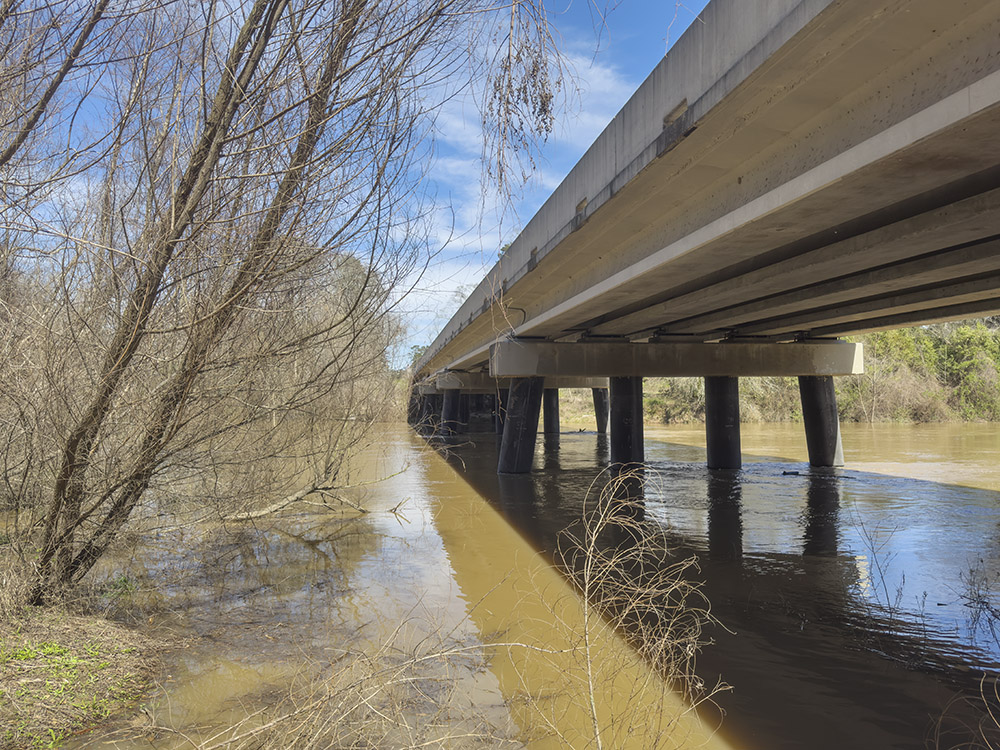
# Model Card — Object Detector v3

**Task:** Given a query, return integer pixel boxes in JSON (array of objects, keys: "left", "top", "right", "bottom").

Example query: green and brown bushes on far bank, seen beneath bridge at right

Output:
[{"left": 643, "top": 318, "right": 1000, "bottom": 423}]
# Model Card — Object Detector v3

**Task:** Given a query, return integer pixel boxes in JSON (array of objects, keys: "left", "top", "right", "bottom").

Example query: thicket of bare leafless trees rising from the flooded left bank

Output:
[{"left": 0, "top": 0, "right": 559, "bottom": 601}]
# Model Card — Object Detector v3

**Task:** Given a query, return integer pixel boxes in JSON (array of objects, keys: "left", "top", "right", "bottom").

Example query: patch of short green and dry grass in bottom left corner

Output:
[{"left": 0, "top": 608, "right": 153, "bottom": 750}]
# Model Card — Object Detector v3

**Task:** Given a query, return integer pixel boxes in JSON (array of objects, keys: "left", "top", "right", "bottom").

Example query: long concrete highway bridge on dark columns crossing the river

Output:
[{"left": 411, "top": 0, "right": 1000, "bottom": 473}]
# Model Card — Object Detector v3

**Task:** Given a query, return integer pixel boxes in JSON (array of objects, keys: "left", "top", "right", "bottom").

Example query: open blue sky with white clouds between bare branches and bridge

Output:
[{"left": 399, "top": 0, "right": 708, "bottom": 364}]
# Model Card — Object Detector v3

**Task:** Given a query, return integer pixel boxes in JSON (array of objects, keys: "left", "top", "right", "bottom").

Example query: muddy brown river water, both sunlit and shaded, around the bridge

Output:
[{"left": 74, "top": 424, "right": 1000, "bottom": 750}]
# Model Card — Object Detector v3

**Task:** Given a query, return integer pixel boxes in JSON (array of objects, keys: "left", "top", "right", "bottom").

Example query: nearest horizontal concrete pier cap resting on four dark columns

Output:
[{"left": 490, "top": 340, "right": 864, "bottom": 378}]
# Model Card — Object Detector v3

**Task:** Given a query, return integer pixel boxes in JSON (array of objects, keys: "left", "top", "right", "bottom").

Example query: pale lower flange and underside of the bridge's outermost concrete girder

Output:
[{"left": 500, "top": 89, "right": 1000, "bottom": 350}]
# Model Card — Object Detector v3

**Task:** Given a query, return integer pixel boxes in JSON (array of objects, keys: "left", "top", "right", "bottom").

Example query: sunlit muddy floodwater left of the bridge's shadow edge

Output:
[{"left": 70, "top": 426, "right": 728, "bottom": 750}]
